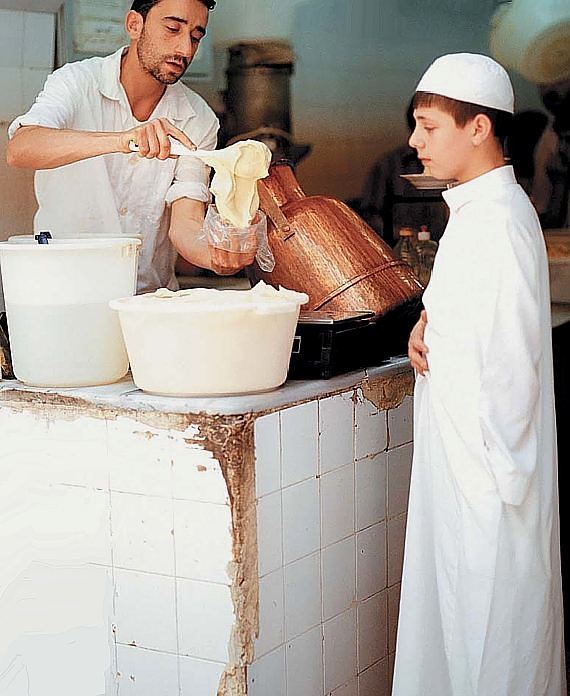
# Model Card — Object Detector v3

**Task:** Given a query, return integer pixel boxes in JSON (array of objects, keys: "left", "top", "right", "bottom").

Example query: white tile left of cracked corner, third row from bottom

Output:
[{"left": 174, "top": 500, "right": 233, "bottom": 585}]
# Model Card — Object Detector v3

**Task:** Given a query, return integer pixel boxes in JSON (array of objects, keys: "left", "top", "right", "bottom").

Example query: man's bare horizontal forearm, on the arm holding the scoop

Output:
[{"left": 6, "top": 126, "right": 121, "bottom": 169}]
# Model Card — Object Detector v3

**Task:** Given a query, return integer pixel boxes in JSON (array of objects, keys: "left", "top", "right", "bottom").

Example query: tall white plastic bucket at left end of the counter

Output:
[{"left": 0, "top": 238, "right": 141, "bottom": 387}]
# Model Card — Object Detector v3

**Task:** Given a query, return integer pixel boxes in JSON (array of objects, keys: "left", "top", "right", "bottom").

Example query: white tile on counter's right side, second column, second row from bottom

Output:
[{"left": 285, "top": 553, "right": 321, "bottom": 640}]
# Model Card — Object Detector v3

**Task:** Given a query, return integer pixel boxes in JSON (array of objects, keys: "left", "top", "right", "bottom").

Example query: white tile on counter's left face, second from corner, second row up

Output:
[{"left": 115, "top": 570, "right": 177, "bottom": 653}]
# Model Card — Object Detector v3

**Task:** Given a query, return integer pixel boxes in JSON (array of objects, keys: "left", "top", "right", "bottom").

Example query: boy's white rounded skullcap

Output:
[{"left": 416, "top": 53, "right": 515, "bottom": 114}]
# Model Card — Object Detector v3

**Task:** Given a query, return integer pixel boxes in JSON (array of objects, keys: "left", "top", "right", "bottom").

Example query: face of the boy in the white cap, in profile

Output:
[{"left": 409, "top": 106, "right": 474, "bottom": 182}]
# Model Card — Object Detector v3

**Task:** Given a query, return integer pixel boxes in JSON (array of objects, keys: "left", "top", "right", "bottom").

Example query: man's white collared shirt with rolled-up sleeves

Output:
[{"left": 9, "top": 48, "right": 219, "bottom": 292}]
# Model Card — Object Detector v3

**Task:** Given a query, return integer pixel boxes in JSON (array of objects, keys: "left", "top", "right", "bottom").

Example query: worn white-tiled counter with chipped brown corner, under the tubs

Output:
[{"left": 0, "top": 360, "right": 412, "bottom": 696}]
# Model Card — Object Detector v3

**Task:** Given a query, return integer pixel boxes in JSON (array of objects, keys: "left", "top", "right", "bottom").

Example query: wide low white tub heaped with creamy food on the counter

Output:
[{"left": 110, "top": 283, "right": 309, "bottom": 396}]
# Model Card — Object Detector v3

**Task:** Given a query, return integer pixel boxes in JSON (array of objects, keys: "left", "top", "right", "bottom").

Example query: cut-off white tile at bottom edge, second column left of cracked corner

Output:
[{"left": 117, "top": 645, "right": 178, "bottom": 696}]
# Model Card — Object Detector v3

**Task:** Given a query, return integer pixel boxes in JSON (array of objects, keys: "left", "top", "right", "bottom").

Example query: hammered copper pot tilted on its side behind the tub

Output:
[{"left": 256, "top": 162, "right": 423, "bottom": 316}]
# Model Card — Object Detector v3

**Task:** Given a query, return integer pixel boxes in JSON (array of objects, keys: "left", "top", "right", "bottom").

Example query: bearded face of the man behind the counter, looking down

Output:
[{"left": 136, "top": 0, "right": 208, "bottom": 85}]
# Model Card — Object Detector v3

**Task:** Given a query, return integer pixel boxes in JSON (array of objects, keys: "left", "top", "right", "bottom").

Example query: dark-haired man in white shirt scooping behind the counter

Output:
[{"left": 7, "top": 0, "right": 253, "bottom": 291}]
